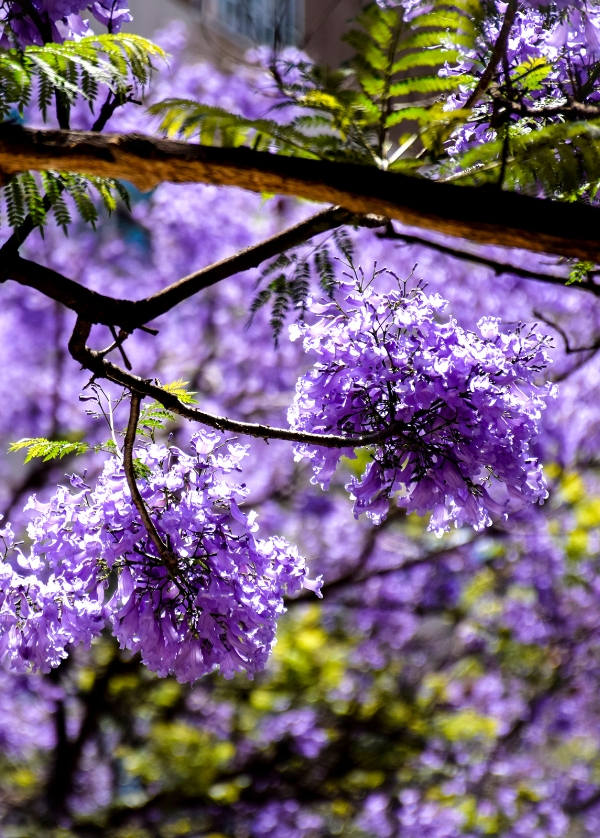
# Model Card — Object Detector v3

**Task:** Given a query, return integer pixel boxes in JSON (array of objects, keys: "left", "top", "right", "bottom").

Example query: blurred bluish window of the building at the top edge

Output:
[{"left": 218, "top": 0, "right": 301, "bottom": 44}]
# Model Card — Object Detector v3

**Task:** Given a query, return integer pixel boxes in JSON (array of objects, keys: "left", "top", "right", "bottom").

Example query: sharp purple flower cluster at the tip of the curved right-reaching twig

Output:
[{"left": 288, "top": 271, "right": 549, "bottom": 535}]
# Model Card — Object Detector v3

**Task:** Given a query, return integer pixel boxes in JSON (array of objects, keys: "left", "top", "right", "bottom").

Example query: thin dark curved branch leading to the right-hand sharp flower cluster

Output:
[{"left": 69, "top": 318, "right": 406, "bottom": 450}]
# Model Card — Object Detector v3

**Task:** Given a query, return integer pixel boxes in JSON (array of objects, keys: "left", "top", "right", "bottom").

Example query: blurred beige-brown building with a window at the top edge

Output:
[{"left": 124, "top": 0, "right": 364, "bottom": 66}]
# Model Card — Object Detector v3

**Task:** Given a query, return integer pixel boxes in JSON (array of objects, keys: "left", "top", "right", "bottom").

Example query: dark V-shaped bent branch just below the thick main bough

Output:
[{"left": 0, "top": 207, "right": 366, "bottom": 332}]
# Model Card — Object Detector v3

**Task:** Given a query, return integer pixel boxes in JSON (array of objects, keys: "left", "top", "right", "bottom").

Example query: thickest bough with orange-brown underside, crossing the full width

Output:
[{"left": 0, "top": 125, "right": 600, "bottom": 262}]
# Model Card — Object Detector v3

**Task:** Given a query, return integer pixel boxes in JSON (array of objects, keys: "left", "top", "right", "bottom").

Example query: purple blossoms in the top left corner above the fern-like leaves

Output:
[{"left": 0, "top": 0, "right": 132, "bottom": 48}]
